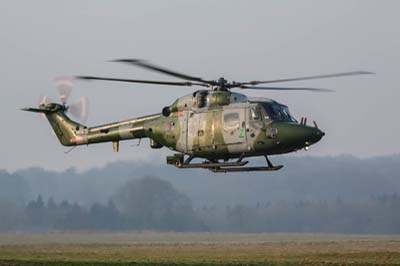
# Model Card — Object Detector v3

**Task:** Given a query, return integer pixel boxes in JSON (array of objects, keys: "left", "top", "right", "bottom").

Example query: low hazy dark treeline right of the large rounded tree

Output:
[{"left": 197, "top": 193, "right": 400, "bottom": 234}]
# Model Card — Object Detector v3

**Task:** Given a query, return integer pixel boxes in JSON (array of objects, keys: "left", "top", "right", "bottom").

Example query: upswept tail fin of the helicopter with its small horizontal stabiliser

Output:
[{"left": 21, "top": 103, "right": 87, "bottom": 146}]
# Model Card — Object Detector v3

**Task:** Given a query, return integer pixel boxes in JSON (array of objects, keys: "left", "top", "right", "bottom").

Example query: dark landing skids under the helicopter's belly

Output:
[{"left": 167, "top": 154, "right": 283, "bottom": 173}]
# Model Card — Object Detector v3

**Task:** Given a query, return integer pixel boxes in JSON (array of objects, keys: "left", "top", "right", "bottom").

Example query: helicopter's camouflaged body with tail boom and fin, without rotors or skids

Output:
[{"left": 43, "top": 90, "right": 324, "bottom": 160}]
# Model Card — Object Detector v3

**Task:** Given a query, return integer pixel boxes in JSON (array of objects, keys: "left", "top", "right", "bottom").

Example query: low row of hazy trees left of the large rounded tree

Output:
[{"left": 0, "top": 195, "right": 123, "bottom": 232}]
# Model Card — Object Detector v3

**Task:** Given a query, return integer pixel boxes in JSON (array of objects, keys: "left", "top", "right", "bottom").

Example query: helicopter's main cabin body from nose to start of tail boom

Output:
[{"left": 145, "top": 91, "right": 324, "bottom": 159}]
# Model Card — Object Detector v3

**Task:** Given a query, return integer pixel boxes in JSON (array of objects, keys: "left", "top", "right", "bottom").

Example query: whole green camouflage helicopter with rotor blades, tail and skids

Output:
[{"left": 22, "top": 59, "right": 372, "bottom": 173}]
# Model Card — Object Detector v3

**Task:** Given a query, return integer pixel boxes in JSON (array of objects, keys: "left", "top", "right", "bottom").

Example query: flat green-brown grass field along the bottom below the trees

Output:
[{"left": 0, "top": 232, "right": 400, "bottom": 266}]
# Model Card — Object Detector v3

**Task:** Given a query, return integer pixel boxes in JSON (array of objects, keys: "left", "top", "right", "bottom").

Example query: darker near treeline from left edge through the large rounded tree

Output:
[{"left": 0, "top": 177, "right": 206, "bottom": 232}]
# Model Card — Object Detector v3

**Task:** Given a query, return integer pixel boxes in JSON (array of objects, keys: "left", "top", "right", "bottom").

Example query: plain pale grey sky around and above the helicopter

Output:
[{"left": 0, "top": 0, "right": 400, "bottom": 171}]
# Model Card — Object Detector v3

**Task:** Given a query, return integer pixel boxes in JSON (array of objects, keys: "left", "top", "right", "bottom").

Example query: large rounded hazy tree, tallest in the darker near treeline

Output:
[{"left": 114, "top": 177, "right": 204, "bottom": 231}]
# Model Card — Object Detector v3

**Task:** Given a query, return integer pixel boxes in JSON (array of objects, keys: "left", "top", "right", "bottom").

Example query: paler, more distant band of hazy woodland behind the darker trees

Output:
[{"left": 11, "top": 154, "right": 400, "bottom": 208}]
